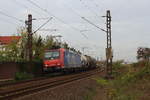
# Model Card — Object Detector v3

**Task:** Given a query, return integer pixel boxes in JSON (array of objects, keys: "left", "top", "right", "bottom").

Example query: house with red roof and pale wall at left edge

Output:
[{"left": 0, "top": 36, "right": 21, "bottom": 51}]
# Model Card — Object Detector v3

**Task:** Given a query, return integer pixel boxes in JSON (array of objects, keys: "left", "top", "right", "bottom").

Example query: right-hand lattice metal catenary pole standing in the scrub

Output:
[{"left": 106, "top": 10, "right": 113, "bottom": 78}]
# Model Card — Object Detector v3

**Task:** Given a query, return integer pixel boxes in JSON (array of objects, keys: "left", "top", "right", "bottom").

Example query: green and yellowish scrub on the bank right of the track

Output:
[{"left": 95, "top": 62, "right": 150, "bottom": 100}]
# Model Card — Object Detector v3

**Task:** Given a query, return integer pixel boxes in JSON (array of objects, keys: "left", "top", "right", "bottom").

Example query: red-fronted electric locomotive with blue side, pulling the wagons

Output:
[{"left": 43, "top": 48, "right": 82, "bottom": 71}]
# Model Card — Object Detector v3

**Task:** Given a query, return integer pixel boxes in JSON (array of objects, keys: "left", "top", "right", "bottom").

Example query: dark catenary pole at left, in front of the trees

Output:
[{"left": 25, "top": 14, "right": 32, "bottom": 62}]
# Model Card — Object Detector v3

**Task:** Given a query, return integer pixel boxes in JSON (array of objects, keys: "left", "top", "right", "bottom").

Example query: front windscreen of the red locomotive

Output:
[{"left": 44, "top": 51, "right": 60, "bottom": 60}]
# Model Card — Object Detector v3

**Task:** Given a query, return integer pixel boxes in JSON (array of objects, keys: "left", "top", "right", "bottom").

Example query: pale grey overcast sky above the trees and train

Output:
[{"left": 0, "top": 0, "right": 150, "bottom": 62}]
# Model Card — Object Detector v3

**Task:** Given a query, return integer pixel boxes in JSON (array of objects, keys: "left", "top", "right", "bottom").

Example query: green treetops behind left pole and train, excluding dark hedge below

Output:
[{"left": 0, "top": 28, "right": 80, "bottom": 62}]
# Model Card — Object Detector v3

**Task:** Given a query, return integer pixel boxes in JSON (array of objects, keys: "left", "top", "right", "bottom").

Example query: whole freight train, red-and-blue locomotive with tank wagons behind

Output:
[{"left": 43, "top": 48, "right": 96, "bottom": 72}]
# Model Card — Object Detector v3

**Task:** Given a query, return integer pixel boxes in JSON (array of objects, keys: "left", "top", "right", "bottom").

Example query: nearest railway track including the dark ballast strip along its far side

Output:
[{"left": 0, "top": 69, "right": 101, "bottom": 100}]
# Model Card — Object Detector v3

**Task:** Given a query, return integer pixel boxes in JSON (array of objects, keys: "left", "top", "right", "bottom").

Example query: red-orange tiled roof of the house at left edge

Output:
[{"left": 0, "top": 36, "right": 21, "bottom": 45}]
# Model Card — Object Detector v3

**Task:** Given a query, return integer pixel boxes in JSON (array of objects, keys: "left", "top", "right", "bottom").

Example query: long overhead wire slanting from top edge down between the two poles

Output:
[{"left": 27, "top": 0, "right": 87, "bottom": 38}]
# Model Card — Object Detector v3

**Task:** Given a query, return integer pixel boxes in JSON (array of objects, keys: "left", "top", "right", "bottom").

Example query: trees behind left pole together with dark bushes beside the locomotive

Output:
[{"left": 0, "top": 28, "right": 80, "bottom": 80}]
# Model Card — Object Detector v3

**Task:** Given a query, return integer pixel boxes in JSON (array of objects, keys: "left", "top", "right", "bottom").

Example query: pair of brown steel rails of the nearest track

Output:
[{"left": 0, "top": 70, "right": 100, "bottom": 100}]
